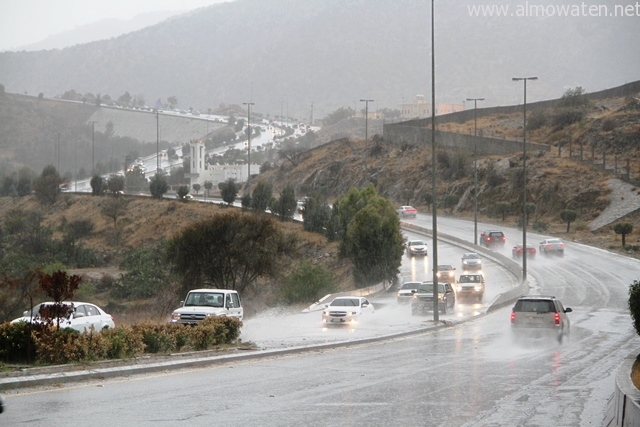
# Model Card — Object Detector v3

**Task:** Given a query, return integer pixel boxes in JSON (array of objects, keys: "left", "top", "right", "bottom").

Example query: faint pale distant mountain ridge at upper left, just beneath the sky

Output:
[{"left": 11, "top": 11, "right": 180, "bottom": 51}]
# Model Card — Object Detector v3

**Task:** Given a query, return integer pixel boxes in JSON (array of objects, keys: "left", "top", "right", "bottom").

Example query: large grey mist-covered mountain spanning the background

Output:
[{"left": 0, "top": 0, "right": 640, "bottom": 119}]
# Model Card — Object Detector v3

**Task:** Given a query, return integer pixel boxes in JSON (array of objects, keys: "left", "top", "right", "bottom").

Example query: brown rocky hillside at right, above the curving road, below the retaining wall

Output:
[{"left": 260, "top": 93, "right": 640, "bottom": 252}]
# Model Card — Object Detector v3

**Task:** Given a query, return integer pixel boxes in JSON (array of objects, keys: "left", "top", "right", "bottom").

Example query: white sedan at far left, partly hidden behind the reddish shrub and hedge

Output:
[{"left": 11, "top": 301, "right": 115, "bottom": 332}]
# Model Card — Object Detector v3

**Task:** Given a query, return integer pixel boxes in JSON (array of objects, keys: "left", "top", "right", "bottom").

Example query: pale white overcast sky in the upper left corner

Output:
[{"left": 0, "top": 0, "right": 231, "bottom": 51}]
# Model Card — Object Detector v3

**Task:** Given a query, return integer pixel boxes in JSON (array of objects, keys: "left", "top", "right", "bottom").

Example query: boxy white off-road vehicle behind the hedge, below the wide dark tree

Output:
[{"left": 171, "top": 289, "right": 243, "bottom": 325}]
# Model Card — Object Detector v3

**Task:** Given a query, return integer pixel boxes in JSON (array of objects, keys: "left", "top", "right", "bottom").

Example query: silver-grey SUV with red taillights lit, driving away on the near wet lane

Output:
[{"left": 511, "top": 296, "right": 573, "bottom": 343}]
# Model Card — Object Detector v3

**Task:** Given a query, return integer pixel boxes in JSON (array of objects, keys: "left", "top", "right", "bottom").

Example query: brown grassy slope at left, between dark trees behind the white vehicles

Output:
[{"left": 0, "top": 194, "right": 355, "bottom": 320}]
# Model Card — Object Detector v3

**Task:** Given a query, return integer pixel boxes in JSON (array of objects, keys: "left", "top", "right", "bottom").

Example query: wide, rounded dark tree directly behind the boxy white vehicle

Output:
[{"left": 167, "top": 211, "right": 295, "bottom": 293}]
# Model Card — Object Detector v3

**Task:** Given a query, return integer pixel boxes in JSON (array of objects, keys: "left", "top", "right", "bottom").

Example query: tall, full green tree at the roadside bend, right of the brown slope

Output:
[{"left": 337, "top": 184, "right": 404, "bottom": 286}]
